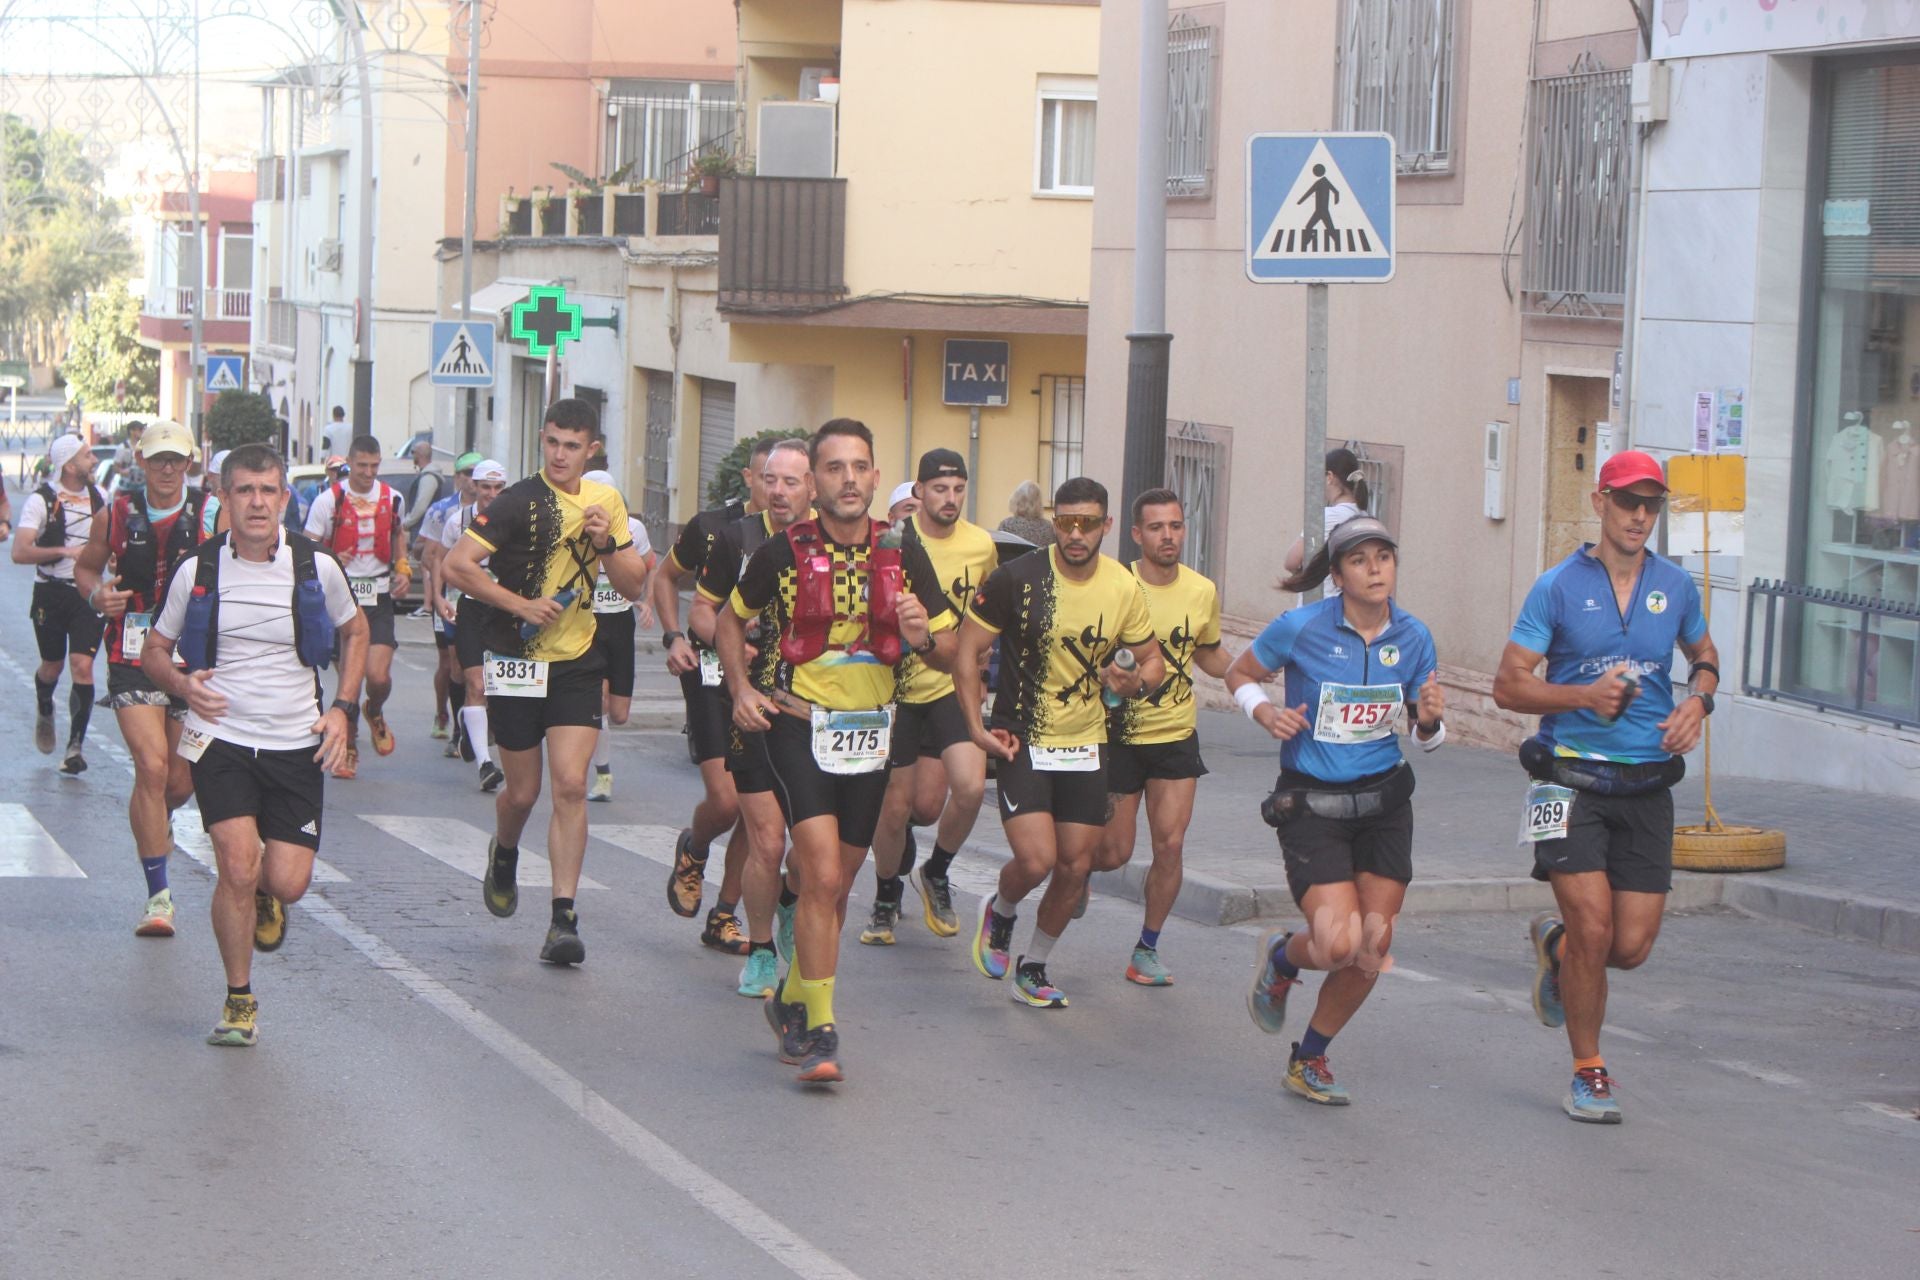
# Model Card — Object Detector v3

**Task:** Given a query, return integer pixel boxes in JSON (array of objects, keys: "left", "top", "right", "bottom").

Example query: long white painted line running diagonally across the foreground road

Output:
[{"left": 300, "top": 890, "right": 860, "bottom": 1280}]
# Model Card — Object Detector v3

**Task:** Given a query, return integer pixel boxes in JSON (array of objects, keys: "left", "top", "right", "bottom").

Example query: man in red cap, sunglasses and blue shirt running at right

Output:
[{"left": 1494, "top": 451, "right": 1720, "bottom": 1125}]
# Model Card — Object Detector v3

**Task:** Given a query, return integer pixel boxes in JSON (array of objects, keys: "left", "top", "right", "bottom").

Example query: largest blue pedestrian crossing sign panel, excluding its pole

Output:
[{"left": 1246, "top": 132, "right": 1394, "bottom": 284}]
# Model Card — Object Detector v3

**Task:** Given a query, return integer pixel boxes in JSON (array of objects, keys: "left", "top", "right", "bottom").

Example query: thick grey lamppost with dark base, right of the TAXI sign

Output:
[{"left": 1121, "top": 0, "right": 1173, "bottom": 558}]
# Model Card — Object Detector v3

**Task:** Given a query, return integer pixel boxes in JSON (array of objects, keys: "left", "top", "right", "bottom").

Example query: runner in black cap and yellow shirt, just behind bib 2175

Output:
[{"left": 860, "top": 449, "right": 998, "bottom": 946}]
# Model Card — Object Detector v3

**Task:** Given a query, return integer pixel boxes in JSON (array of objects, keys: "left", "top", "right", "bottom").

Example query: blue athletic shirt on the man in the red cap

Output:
[{"left": 1509, "top": 543, "right": 1707, "bottom": 764}]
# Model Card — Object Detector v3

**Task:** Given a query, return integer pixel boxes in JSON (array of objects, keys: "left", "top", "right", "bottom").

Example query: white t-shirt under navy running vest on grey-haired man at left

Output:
[{"left": 154, "top": 537, "right": 359, "bottom": 750}]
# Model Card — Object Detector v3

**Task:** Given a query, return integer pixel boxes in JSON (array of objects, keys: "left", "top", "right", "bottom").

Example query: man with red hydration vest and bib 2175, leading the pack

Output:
[{"left": 718, "top": 418, "right": 954, "bottom": 1084}]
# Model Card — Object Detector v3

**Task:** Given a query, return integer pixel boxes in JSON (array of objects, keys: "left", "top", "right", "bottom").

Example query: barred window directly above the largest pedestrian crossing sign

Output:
[{"left": 1334, "top": 0, "right": 1453, "bottom": 173}]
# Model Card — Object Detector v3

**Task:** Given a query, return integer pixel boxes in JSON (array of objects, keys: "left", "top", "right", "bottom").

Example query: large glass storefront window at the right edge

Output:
[{"left": 1788, "top": 63, "right": 1920, "bottom": 718}]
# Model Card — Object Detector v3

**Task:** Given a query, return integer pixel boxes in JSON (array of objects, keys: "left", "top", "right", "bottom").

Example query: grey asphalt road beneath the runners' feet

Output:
[{"left": 0, "top": 564, "right": 1920, "bottom": 1280}]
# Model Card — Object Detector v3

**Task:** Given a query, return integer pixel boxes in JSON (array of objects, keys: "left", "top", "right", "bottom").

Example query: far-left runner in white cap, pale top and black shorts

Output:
[{"left": 13, "top": 436, "right": 108, "bottom": 777}]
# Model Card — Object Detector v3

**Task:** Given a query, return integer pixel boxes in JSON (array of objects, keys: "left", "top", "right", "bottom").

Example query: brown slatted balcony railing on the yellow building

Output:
[{"left": 720, "top": 178, "right": 847, "bottom": 311}]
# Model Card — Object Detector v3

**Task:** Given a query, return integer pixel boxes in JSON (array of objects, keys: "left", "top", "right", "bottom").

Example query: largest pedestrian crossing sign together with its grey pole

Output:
[{"left": 1246, "top": 132, "right": 1396, "bottom": 601}]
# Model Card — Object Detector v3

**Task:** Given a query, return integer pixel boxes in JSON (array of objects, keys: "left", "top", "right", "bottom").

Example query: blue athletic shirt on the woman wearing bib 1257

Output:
[{"left": 1254, "top": 595, "right": 1438, "bottom": 783}]
